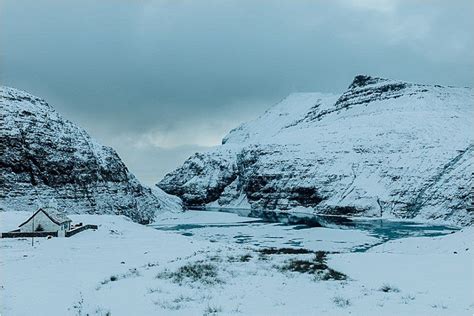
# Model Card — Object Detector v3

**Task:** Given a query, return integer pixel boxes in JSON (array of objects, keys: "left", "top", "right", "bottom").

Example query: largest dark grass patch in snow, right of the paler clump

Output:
[{"left": 279, "top": 251, "right": 347, "bottom": 281}]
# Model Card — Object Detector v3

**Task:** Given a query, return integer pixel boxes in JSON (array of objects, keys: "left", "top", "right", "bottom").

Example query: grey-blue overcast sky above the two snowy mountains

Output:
[{"left": 0, "top": 0, "right": 474, "bottom": 184}]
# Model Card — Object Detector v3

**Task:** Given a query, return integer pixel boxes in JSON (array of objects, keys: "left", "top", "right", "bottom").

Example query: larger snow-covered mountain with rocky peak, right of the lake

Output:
[{"left": 157, "top": 76, "right": 474, "bottom": 225}]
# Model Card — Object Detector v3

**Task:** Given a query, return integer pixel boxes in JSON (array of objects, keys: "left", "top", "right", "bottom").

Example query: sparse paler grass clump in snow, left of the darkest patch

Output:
[{"left": 156, "top": 261, "right": 223, "bottom": 285}]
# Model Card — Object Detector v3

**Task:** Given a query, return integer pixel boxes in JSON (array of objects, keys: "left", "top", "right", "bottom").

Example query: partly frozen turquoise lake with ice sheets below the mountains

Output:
[{"left": 151, "top": 209, "right": 458, "bottom": 252}]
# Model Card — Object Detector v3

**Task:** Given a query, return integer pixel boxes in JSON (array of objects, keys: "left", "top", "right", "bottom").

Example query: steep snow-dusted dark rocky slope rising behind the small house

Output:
[{"left": 0, "top": 87, "right": 181, "bottom": 223}]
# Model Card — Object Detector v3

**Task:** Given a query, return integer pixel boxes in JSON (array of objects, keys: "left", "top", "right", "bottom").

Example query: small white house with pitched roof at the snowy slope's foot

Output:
[{"left": 20, "top": 207, "right": 71, "bottom": 233}]
